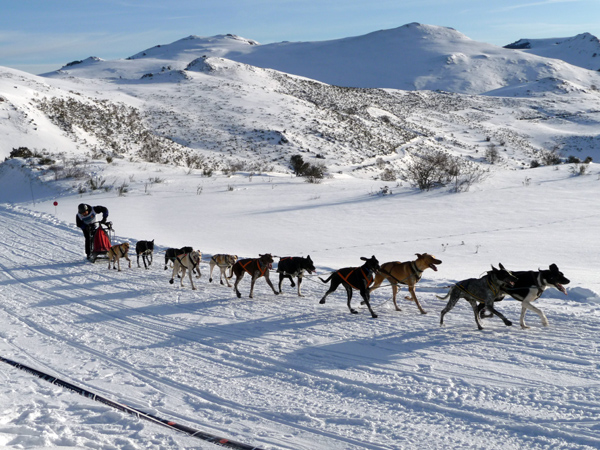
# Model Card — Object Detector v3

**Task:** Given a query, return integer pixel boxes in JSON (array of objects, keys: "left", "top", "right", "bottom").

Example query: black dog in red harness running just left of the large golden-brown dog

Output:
[{"left": 319, "top": 255, "right": 379, "bottom": 319}]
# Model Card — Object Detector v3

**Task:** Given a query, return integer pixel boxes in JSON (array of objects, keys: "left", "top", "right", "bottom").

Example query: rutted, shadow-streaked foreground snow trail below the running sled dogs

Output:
[{"left": 0, "top": 206, "right": 600, "bottom": 449}]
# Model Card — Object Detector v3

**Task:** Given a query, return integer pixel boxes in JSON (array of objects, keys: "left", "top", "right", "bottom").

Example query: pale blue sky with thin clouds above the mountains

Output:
[{"left": 0, "top": 0, "right": 600, "bottom": 74}]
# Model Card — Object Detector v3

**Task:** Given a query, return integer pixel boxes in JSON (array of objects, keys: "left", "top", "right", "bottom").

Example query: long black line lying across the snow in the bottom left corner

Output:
[{"left": 0, "top": 356, "right": 262, "bottom": 450}]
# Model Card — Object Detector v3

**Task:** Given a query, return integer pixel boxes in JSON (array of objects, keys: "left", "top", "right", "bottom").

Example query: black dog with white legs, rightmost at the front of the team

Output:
[{"left": 479, "top": 264, "right": 571, "bottom": 328}]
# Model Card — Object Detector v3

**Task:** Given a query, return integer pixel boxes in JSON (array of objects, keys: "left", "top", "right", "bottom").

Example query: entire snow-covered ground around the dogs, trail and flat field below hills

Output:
[{"left": 0, "top": 160, "right": 600, "bottom": 450}]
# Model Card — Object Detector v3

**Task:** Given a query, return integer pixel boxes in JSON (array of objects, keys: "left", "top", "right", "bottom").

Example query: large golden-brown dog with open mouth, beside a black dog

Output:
[{"left": 370, "top": 253, "right": 442, "bottom": 314}]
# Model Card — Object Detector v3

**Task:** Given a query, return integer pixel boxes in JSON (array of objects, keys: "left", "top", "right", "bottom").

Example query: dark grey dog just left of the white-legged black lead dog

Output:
[{"left": 437, "top": 264, "right": 517, "bottom": 330}]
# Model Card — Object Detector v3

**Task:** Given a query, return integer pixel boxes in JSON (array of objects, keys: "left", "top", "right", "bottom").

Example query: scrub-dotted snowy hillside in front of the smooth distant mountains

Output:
[{"left": 0, "top": 55, "right": 600, "bottom": 178}]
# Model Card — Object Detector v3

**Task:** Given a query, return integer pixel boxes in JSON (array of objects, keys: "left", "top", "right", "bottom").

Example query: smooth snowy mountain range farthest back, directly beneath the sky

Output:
[{"left": 47, "top": 23, "right": 600, "bottom": 94}]
